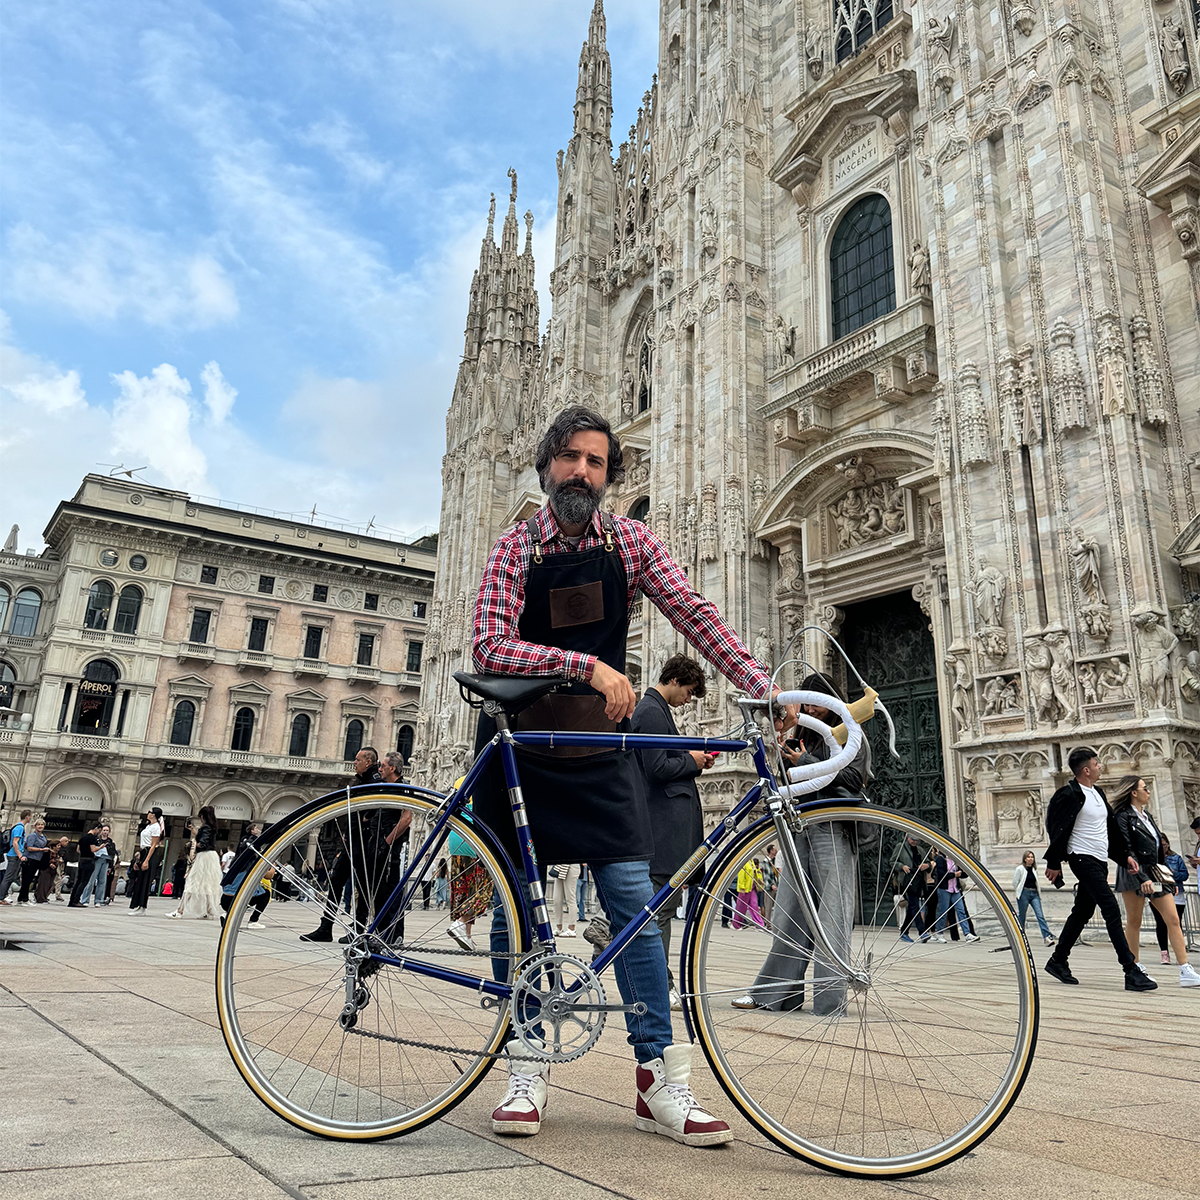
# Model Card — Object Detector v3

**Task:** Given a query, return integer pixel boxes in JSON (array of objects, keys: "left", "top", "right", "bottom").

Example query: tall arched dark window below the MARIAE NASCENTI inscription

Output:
[{"left": 829, "top": 193, "right": 896, "bottom": 341}]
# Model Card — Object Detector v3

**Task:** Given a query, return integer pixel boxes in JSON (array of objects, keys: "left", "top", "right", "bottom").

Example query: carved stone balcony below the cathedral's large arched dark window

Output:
[{"left": 762, "top": 296, "right": 937, "bottom": 451}]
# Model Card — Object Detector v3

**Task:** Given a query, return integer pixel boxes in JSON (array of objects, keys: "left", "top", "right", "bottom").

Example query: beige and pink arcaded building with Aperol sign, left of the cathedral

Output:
[{"left": 0, "top": 475, "right": 434, "bottom": 857}]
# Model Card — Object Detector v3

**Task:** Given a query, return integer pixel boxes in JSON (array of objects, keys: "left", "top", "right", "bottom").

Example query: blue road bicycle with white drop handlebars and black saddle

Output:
[{"left": 216, "top": 674, "right": 1038, "bottom": 1177}]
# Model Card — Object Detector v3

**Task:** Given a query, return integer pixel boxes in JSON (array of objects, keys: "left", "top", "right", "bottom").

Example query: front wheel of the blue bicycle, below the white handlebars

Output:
[{"left": 688, "top": 804, "right": 1038, "bottom": 1177}]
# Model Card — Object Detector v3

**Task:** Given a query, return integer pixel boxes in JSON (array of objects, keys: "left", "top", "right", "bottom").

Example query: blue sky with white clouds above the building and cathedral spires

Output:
[{"left": 0, "top": 0, "right": 658, "bottom": 552}]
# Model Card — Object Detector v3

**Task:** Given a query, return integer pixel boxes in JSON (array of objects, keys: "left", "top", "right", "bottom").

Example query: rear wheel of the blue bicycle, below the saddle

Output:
[{"left": 216, "top": 787, "right": 522, "bottom": 1140}]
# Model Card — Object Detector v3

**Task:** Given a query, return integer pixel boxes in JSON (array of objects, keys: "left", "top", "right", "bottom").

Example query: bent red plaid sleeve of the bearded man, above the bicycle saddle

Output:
[{"left": 475, "top": 523, "right": 596, "bottom": 683}]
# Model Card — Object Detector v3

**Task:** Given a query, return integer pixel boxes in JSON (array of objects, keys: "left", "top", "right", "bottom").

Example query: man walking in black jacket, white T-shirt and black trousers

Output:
[{"left": 1045, "top": 746, "right": 1158, "bottom": 991}]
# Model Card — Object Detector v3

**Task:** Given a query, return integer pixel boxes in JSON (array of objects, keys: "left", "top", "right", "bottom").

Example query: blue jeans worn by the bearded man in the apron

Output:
[{"left": 491, "top": 862, "right": 674, "bottom": 1062}]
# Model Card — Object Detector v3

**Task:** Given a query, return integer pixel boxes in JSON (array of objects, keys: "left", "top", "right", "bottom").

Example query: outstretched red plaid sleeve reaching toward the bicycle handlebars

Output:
[{"left": 617, "top": 518, "right": 770, "bottom": 696}]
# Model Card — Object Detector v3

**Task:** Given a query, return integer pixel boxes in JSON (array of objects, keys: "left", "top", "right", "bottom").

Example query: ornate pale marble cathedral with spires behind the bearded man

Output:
[{"left": 418, "top": 0, "right": 1200, "bottom": 865}]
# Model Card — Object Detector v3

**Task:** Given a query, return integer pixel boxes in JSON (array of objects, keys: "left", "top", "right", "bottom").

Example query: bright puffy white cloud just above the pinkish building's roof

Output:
[{"left": 113, "top": 362, "right": 208, "bottom": 492}]
